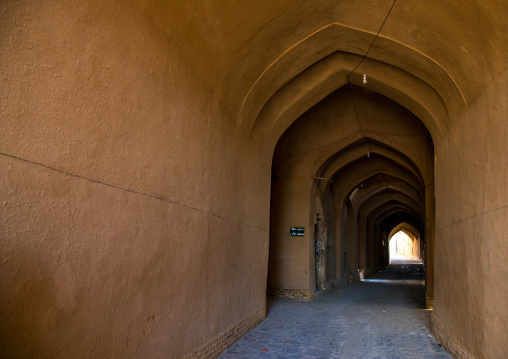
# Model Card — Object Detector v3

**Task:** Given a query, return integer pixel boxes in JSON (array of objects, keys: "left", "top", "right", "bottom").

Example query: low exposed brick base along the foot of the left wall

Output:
[{"left": 185, "top": 308, "right": 266, "bottom": 359}]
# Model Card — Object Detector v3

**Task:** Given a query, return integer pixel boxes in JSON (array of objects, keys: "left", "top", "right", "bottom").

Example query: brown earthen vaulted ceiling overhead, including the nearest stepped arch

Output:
[{"left": 132, "top": 0, "right": 507, "bottom": 140}]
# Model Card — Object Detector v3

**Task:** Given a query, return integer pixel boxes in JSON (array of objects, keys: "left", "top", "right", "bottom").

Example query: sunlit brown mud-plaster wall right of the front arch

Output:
[{"left": 434, "top": 70, "right": 508, "bottom": 358}]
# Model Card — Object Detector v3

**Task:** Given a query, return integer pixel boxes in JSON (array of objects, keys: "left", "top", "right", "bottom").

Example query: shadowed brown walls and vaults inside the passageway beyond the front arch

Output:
[{"left": 268, "top": 86, "right": 434, "bottom": 307}]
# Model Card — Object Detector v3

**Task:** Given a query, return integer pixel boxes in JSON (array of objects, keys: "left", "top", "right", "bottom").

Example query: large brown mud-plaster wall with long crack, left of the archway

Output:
[{"left": 0, "top": 1, "right": 271, "bottom": 358}]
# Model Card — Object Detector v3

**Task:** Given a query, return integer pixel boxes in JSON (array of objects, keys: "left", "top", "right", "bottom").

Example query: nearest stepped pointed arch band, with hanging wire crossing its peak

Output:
[{"left": 238, "top": 23, "right": 467, "bottom": 146}]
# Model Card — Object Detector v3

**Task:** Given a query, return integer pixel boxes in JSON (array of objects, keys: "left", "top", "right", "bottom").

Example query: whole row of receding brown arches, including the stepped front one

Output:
[{"left": 225, "top": 22, "right": 460, "bottom": 307}]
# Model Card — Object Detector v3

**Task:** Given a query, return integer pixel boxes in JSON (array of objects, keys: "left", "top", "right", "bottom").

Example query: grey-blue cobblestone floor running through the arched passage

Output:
[{"left": 219, "top": 261, "right": 451, "bottom": 359}]
